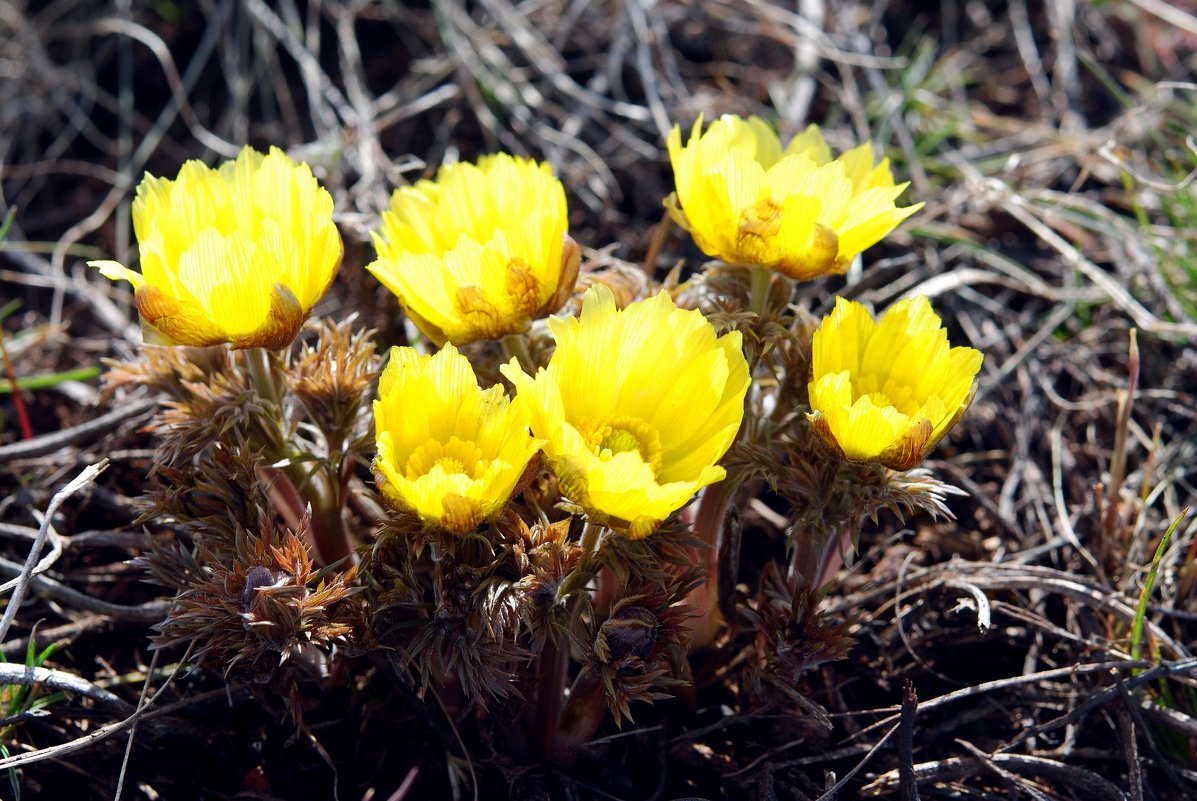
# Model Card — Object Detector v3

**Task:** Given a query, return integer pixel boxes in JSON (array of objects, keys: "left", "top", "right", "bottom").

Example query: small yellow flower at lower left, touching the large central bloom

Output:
[{"left": 373, "top": 345, "right": 543, "bottom": 534}]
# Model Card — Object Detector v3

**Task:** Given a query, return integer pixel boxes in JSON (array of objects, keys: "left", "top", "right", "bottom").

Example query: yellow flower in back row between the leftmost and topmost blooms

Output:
[{"left": 366, "top": 153, "right": 581, "bottom": 345}]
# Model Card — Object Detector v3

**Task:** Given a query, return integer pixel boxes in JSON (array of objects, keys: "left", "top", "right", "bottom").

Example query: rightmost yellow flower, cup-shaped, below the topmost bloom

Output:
[{"left": 808, "top": 296, "right": 983, "bottom": 471}]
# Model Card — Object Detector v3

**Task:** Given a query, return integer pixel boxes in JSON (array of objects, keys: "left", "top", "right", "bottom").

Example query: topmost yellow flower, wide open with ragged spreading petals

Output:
[{"left": 666, "top": 114, "right": 923, "bottom": 280}]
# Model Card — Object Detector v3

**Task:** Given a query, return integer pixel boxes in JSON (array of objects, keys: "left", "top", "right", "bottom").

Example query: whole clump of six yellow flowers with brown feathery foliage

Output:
[{"left": 92, "top": 116, "right": 982, "bottom": 759}]
